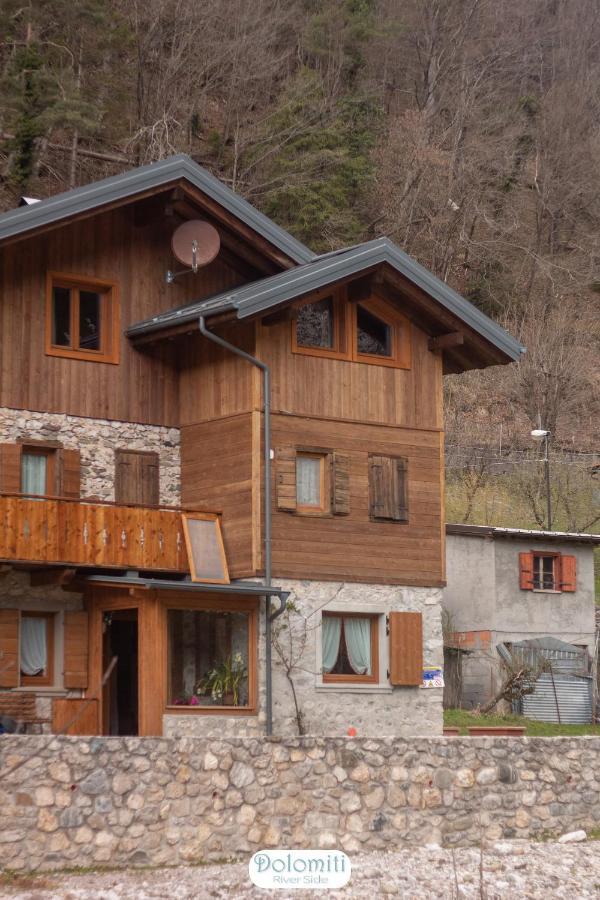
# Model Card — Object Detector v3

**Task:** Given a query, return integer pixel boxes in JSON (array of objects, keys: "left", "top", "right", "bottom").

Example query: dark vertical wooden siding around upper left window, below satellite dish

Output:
[{"left": 0, "top": 204, "right": 244, "bottom": 425}]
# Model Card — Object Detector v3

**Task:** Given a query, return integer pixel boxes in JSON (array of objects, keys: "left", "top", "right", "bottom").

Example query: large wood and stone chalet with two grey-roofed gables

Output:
[{"left": 0, "top": 156, "right": 522, "bottom": 735}]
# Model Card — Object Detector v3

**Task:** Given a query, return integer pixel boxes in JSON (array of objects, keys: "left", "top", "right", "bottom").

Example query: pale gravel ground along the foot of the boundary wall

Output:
[{"left": 0, "top": 841, "right": 600, "bottom": 900}]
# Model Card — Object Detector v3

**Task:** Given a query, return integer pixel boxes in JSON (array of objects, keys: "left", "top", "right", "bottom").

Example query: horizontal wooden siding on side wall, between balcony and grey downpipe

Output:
[{"left": 181, "top": 413, "right": 260, "bottom": 578}]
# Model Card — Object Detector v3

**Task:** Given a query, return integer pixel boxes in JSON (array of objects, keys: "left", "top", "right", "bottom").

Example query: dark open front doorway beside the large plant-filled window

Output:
[{"left": 102, "top": 609, "right": 139, "bottom": 735}]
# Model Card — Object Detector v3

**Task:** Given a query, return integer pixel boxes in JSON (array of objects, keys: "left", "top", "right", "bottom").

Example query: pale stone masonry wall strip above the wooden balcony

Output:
[{"left": 0, "top": 408, "right": 181, "bottom": 506}]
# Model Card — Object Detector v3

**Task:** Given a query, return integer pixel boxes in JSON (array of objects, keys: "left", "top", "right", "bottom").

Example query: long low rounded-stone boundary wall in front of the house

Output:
[{"left": 0, "top": 736, "right": 600, "bottom": 871}]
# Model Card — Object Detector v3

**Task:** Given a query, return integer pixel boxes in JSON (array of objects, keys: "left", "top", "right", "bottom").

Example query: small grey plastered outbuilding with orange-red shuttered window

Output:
[{"left": 443, "top": 524, "right": 600, "bottom": 709}]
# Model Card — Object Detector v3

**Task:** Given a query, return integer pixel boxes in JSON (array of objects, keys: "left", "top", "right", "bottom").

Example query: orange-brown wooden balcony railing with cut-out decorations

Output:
[{"left": 0, "top": 494, "right": 195, "bottom": 572}]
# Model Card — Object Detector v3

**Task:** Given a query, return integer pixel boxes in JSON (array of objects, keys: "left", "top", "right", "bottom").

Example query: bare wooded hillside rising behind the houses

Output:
[{"left": 0, "top": 0, "right": 600, "bottom": 529}]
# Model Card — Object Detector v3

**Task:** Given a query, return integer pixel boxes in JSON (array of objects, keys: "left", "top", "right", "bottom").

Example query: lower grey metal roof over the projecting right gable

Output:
[{"left": 127, "top": 238, "right": 524, "bottom": 359}]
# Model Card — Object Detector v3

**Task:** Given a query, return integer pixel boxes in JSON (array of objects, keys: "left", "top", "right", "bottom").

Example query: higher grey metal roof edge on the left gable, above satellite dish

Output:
[{"left": 0, "top": 154, "right": 315, "bottom": 263}]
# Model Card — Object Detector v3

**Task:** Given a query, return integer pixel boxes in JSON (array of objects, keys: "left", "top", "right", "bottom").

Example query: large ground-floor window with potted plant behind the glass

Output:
[{"left": 166, "top": 601, "right": 258, "bottom": 715}]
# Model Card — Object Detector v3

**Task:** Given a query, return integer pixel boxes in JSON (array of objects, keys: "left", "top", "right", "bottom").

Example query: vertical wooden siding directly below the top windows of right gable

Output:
[{"left": 257, "top": 312, "right": 443, "bottom": 428}]
